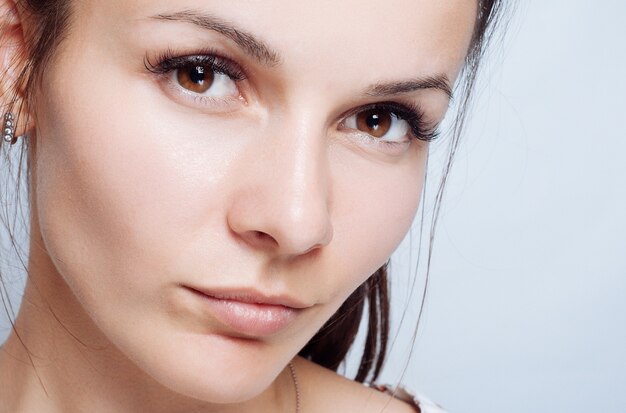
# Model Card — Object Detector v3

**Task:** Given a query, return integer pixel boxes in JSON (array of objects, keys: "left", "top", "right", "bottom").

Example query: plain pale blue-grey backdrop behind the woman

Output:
[{"left": 0, "top": 0, "right": 626, "bottom": 413}]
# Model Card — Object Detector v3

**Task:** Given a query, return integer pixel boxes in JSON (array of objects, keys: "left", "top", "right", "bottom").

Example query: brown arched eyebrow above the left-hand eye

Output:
[{"left": 151, "top": 10, "right": 281, "bottom": 66}]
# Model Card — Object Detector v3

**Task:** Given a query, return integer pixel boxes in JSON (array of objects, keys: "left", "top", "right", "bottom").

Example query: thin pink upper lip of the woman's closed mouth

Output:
[{"left": 184, "top": 285, "right": 312, "bottom": 309}]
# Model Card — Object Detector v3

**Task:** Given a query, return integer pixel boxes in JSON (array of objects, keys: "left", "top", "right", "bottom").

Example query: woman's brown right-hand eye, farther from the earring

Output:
[{"left": 345, "top": 108, "right": 411, "bottom": 142}]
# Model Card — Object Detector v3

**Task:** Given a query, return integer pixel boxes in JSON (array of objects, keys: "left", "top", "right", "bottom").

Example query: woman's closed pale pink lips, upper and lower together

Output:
[{"left": 183, "top": 286, "right": 310, "bottom": 337}]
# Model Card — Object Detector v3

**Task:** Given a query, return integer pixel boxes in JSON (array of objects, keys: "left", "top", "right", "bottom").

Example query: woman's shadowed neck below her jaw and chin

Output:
[{"left": 0, "top": 235, "right": 295, "bottom": 413}]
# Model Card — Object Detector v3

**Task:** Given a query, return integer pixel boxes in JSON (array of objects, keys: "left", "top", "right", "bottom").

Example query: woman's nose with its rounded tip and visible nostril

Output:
[{"left": 227, "top": 119, "right": 333, "bottom": 256}]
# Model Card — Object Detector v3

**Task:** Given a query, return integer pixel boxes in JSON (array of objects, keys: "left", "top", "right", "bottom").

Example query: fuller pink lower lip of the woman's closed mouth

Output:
[{"left": 184, "top": 289, "right": 301, "bottom": 337}]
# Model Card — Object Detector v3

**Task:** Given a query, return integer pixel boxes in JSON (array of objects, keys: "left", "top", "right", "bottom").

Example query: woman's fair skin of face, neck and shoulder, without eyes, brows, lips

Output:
[{"left": 0, "top": 0, "right": 476, "bottom": 413}]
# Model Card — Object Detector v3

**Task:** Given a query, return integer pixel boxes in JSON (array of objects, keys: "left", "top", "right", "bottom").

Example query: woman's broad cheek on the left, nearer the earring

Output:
[{"left": 35, "top": 57, "right": 243, "bottom": 312}]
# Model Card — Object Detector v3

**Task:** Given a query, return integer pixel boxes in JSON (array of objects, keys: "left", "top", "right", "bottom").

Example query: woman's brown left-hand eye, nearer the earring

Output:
[{"left": 172, "top": 65, "right": 238, "bottom": 97}]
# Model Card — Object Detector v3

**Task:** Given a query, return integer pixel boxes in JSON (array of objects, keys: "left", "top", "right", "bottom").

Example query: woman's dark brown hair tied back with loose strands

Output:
[{"left": 0, "top": 0, "right": 506, "bottom": 382}]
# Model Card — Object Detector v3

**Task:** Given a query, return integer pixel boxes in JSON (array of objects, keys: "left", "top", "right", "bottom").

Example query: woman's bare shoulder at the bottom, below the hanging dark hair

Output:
[{"left": 295, "top": 358, "right": 418, "bottom": 413}]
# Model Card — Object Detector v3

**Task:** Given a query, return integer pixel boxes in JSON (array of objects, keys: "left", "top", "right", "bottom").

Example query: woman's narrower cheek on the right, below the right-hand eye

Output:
[{"left": 317, "top": 142, "right": 428, "bottom": 305}]
